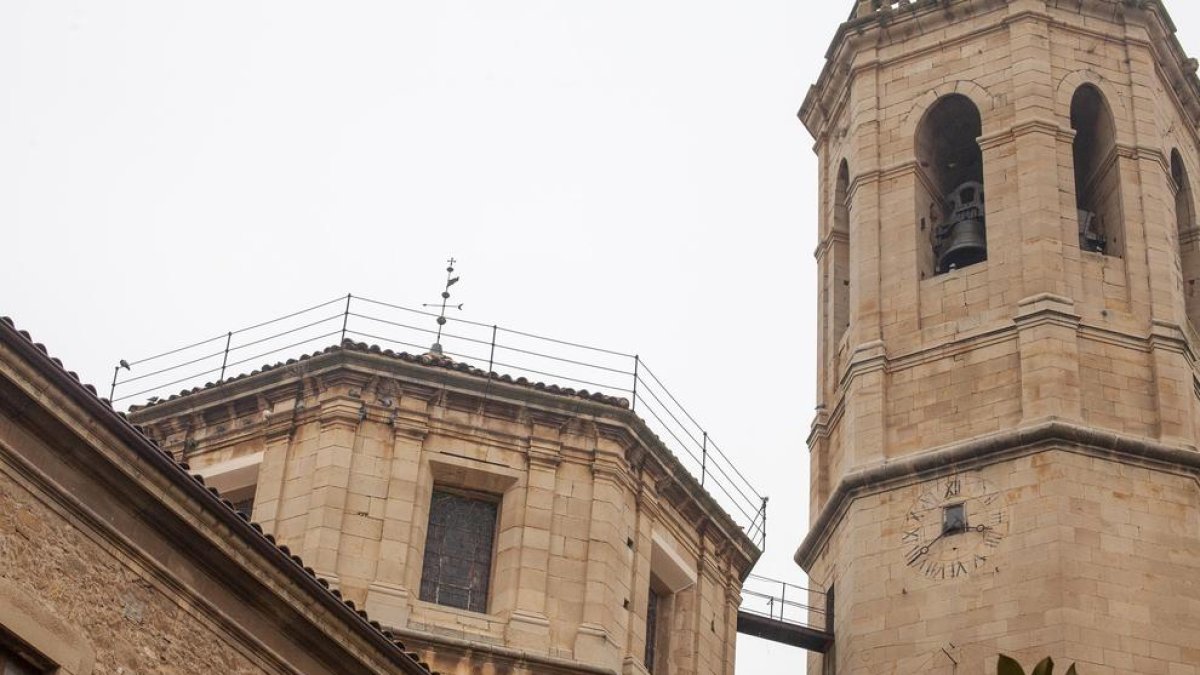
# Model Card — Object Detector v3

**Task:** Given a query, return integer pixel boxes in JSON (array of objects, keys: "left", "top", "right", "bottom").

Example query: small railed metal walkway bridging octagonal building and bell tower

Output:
[{"left": 738, "top": 574, "right": 833, "bottom": 653}]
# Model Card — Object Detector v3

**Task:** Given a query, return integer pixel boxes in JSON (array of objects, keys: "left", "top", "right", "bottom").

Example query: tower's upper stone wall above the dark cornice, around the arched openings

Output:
[{"left": 802, "top": 0, "right": 1200, "bottom": 487}]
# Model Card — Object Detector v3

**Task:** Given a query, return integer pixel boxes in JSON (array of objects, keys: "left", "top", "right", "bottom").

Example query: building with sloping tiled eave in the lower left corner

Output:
[{"left": 0, "top": 318, "right": 439, "bottom": 675}]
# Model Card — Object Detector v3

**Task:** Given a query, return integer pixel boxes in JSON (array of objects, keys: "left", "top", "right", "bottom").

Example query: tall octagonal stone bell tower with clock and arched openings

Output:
[{"left": 796, "top": 0, "right": 1200, "bottom": 675}]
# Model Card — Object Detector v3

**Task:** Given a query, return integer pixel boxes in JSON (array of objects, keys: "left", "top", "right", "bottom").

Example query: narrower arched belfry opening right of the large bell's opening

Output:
[{"left": 1070, "top": 84, "right": 1122, "bottom": 256}]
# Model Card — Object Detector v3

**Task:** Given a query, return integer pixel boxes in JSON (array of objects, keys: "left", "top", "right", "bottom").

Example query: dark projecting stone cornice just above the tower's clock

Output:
[{"left": 794, "top": 419, "right": 1200, "bottom": 571}]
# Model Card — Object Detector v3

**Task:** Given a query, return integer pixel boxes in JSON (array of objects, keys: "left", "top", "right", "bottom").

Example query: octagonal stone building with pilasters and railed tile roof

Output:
[{"left": 131, "top": 342, "right": 760, "bottom": 675}]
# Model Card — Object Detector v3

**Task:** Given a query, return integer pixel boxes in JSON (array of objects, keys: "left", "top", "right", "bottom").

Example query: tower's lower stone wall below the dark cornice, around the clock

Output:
[{"left": 809, "top": 448, "right": 1200, "bottom": 675}]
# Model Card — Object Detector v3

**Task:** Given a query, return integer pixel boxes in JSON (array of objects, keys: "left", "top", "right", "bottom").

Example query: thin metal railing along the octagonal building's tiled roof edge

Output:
[{"left": 109, "top": 294, "right": 767, "bottom": 549}]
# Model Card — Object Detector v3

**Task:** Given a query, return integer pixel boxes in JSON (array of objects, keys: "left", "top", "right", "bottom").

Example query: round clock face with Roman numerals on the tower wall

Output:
[{"left": 900, "top": 473, "right": 1008, "bottom": 581}]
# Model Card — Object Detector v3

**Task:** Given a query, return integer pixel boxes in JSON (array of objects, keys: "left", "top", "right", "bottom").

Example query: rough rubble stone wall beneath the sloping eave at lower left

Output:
[{"left": 0, "top": 464, "right": 265, "bottom": 675}]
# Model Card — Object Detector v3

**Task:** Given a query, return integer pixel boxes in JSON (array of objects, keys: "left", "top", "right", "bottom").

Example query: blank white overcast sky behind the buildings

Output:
[{"left": 7, "top": 0, "right": 1200, "bottom": 674}]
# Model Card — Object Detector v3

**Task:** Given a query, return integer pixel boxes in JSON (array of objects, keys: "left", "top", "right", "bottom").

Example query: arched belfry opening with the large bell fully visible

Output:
[{"left": 917, "top": 94, "right": 988, "bottom": 274}]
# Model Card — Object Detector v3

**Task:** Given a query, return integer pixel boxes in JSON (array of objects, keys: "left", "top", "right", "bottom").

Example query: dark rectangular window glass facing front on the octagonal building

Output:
[{"left": 421, "top": 490, "right": 498, "bottom": 614}]
